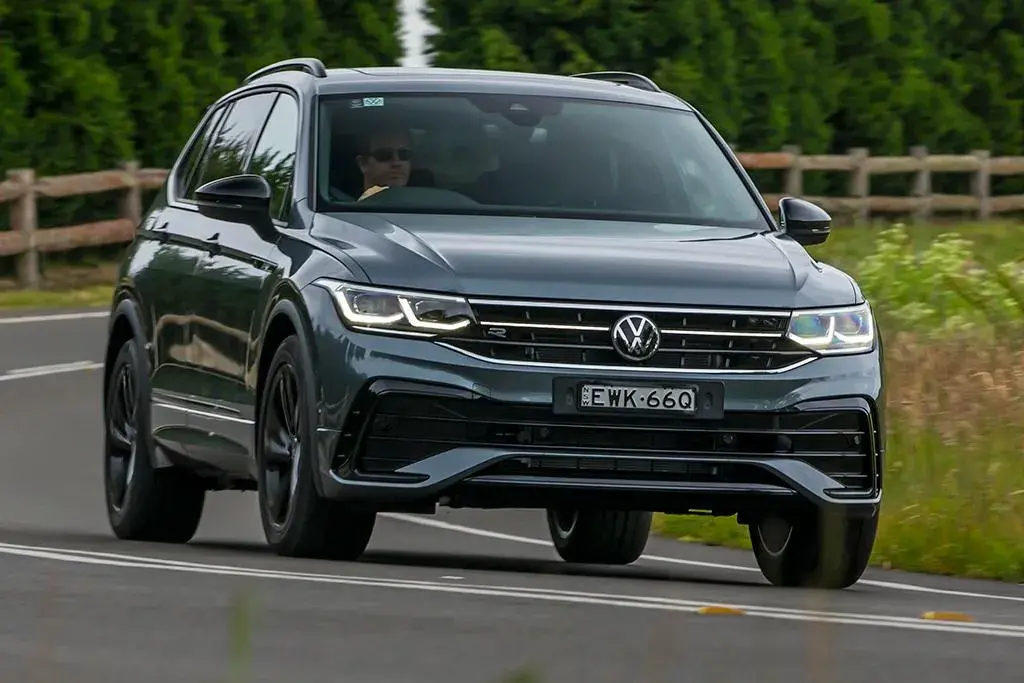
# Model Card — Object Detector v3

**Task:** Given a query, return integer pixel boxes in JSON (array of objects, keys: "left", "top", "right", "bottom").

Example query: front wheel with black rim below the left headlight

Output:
[{"left": 256, "top": 335, "right": 377, "bottom": 560}]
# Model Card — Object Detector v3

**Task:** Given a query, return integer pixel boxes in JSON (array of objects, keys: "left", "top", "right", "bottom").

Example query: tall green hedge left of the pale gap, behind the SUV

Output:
[{"left": 0, "top": 0, "right": 401, "bottom": 240}]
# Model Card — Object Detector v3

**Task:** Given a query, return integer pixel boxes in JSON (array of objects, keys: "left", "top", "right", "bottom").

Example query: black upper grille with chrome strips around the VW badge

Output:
[{"left": 444, "top": 300, "right": 814, "bottom": 372}]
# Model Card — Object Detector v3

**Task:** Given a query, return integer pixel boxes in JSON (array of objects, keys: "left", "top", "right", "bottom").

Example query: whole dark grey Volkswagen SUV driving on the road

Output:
[{"left": 103, "top": 58, "right": 884, "bottom": 587}]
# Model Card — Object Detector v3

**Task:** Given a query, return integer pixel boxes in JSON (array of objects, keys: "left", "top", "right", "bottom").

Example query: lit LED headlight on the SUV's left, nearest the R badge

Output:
[{"left": 316, "top": 280, "right": 473, "bottom": 337}]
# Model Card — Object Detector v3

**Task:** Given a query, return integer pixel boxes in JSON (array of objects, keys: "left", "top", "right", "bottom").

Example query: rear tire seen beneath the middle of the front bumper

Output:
[{"left": 548, "top": 510, "right": 653, "bottom": 564}]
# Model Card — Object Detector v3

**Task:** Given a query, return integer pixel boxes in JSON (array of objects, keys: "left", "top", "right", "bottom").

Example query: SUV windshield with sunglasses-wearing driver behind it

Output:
[{"left": 316, "top": 93, "right": 771, "bottom": 230}]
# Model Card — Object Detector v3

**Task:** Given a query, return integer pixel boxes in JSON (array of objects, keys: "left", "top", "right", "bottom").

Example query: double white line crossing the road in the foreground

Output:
[{"left": 0, "top": 544, "right": 1024, "bottom": 638}]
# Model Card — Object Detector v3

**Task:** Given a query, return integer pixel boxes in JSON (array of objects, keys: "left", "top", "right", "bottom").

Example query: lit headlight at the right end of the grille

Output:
[{"left": 785, "top": 302, "right": 874, "bottom": 355}]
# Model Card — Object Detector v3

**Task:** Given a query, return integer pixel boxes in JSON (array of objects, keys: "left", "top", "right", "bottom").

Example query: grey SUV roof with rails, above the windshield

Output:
[{"left": 237, "top": 60, "right": 693, "bottom": 111}]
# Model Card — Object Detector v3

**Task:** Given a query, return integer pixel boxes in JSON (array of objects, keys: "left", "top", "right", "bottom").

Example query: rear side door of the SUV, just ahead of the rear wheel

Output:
[{"left": 129, "top": 106, "right": 225, "bottom": 456}]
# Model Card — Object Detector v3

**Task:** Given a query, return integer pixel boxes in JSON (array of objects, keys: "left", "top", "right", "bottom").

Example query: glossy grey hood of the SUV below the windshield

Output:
[{"left": 312, "top": 213, "right": 857, "bottom": 308}]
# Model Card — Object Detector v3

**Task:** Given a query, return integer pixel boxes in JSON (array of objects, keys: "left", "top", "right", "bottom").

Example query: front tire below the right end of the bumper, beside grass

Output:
[{"left": 749, "top": 513, "right": 879, "bottom": 589}]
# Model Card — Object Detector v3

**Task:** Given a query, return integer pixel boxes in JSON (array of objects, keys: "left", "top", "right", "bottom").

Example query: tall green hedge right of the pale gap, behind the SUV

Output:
[{"left": 427, "top": 0, "right": 1024, "bottom": 197}]
